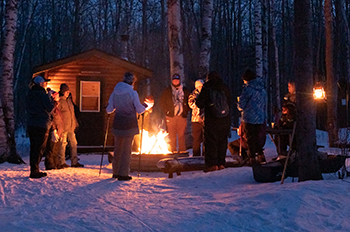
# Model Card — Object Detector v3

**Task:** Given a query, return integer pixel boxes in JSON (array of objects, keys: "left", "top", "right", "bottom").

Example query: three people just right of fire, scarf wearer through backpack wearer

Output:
[{"left": 159, "top": 71, "right": 231, "bottom": 171}]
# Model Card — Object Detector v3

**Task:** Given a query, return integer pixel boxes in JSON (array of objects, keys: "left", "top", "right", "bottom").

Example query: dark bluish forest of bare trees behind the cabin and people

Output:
[{"left": 0, "top": 0, "right": 350, "bottom": 180}]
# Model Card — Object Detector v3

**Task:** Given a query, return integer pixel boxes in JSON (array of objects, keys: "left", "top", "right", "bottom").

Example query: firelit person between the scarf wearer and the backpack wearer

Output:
[{"left": 188, "top": 79, "right": 204, "bottom": 156}]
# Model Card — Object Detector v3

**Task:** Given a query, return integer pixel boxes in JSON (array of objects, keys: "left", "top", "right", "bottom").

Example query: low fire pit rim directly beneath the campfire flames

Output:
[{"left": 130, "top": 152, "right": 188, "bottom": 172}]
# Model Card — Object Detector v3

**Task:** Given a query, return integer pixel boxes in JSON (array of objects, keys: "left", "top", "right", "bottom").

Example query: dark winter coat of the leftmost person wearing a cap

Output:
[{"left": 26, "top": 85, "right": 54, "bottom": 129}]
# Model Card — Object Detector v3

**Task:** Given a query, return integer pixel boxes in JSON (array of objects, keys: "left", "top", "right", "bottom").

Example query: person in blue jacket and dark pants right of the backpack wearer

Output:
[{"left": 237, "top": 69, "right": 267, "bottom": 165}]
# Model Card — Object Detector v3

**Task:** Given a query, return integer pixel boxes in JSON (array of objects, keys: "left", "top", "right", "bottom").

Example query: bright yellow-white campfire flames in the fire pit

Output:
[{"left": 139, "top": 130, "right": 171, "bottom": 154}]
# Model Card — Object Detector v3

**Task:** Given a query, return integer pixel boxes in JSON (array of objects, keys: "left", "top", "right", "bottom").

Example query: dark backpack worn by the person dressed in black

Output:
[{"left": 210, "top": 89, "right": 230, "bottom": 118}]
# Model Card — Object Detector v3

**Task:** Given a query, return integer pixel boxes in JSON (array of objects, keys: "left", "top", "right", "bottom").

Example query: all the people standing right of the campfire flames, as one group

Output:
[{"left": 160, "top": 69, "right": 296, "bottom": 172}]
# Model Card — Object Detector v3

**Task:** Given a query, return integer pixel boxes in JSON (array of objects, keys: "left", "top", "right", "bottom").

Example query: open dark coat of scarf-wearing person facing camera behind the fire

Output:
[{"left": 159, "top": 86, "right": 191, "bottom": 118}]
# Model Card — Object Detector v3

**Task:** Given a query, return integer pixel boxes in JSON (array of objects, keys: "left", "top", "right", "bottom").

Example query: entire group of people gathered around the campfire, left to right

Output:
[{"left": 27, "top": 69, "right": 295, "bottom": 181}]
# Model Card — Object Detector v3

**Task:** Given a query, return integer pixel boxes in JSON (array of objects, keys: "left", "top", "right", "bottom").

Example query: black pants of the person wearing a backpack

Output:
[{"left": 204, "top": 119, "right": 230, "bottom": 167}]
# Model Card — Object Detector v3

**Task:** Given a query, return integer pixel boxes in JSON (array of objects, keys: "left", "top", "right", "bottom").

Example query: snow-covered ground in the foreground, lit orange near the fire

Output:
[{"left": 0, "top": 130, "right": 350, "bottom": 231}]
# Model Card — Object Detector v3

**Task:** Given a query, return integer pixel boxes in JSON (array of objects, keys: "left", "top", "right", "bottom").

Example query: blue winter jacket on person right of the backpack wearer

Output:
[{"left": 237, "top": 78, "right": 267, "bottom": 124}]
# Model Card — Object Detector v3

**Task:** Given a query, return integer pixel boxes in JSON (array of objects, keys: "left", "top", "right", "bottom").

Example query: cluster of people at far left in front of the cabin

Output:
[{"left": 26, "top": 76, "right": 84, "bottom": 178}]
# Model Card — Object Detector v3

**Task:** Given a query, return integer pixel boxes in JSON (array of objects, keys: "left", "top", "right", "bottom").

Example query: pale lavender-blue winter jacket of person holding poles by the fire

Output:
[{"left": 106, "top": 82, "right": 146, "bottom": 136}]
